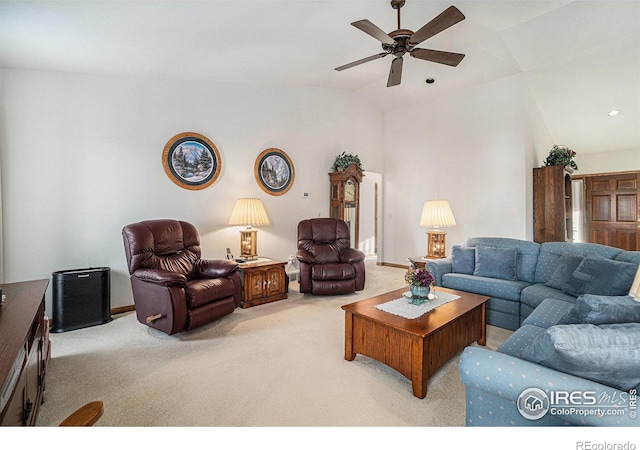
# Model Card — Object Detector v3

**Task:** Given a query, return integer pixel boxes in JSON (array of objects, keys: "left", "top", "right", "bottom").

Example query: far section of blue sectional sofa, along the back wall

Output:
[{"left": 425, "top": 237, "right": 640, "bottom": 330}]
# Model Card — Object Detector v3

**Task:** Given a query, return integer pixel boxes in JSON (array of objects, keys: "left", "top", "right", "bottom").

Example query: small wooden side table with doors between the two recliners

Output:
[{"left": 239, "top": 258, "right": 289, "bottom": 308}]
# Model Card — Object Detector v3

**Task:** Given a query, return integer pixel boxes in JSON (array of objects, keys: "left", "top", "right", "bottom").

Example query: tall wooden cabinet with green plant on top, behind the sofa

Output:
[{"left": 533, "top": 166, "right": 573, "bottom": 244}]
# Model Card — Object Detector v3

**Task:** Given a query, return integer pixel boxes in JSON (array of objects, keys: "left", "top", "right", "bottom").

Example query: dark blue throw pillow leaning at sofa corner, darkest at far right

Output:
[{"left": 562, "top": 255, "right": 638, "bottom": 297}]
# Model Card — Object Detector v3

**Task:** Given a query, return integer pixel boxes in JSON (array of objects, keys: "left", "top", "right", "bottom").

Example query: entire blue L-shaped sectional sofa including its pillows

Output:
[{"left": 426, "top": 237, "right": 640, "bottom": 426}]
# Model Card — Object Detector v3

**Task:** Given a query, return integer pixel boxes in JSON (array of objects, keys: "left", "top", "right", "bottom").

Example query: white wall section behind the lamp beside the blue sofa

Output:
[{"left": 383, "top": 76, "right": 535, "bottom": 264}]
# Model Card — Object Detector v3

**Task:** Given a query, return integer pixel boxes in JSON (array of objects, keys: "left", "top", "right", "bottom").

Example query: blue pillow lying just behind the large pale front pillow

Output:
[{"left": 557, "top": 294, "right": 640, "bottom": 325}]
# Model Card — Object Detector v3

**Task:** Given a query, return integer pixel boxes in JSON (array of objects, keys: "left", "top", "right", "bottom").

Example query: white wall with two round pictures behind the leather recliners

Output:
[{"left": 0, "top": 70, "right": 383, "bottom": 312}]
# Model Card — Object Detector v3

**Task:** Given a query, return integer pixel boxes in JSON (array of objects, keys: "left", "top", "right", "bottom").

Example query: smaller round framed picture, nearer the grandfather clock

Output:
[{"left": 254, "top": 148, "right": 295, "bottom": 195}]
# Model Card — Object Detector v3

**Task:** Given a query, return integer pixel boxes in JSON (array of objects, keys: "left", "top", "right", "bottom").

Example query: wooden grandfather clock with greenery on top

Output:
[{"left": 329, "top": 163, "right": 364, "bottom": 248}]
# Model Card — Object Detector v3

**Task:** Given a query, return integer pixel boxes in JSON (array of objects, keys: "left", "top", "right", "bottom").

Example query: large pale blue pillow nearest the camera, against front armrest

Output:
[{"left": 520, "top": 323, "right": 640, "bottom": 391}]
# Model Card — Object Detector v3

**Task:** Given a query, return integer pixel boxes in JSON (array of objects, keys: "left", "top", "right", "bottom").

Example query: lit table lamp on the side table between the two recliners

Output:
[{"left": 229, "top": 198, "right": 270, "bottom": 260}]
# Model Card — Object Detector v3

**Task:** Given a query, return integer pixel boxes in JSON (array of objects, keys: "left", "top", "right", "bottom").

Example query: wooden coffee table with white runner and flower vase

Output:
[{"left": 342, "top": 287, "right": 489, "bottom": 398}]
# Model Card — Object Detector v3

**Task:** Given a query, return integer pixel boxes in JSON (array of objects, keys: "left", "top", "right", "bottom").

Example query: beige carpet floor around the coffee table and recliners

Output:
[{"left": 37, "top": 262, "right": 510, "bottom": 427}]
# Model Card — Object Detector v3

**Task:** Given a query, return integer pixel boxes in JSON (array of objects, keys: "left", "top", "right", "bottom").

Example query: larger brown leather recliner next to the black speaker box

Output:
[{"left": 122, "top": 219, "right": 242, "bottom": 334}]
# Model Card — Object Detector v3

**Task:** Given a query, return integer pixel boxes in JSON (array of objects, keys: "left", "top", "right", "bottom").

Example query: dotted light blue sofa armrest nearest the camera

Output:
[{"left": 459, "top": 346, "right": 640, "bottom": 427}]
